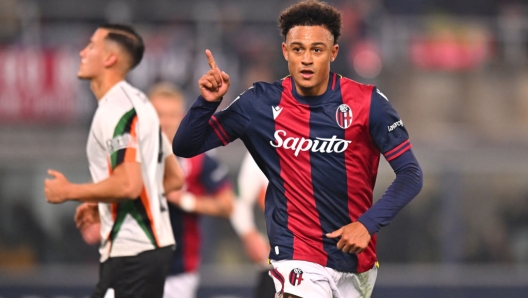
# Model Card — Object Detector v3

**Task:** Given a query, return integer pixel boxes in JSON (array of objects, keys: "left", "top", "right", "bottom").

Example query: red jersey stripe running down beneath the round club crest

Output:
[{"left": 340, "top": 78, "right": 380, "bottom": 273}]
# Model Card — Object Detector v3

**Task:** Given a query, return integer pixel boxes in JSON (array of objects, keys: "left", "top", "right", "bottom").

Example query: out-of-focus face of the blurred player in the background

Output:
[{"left": 150, "top": 95, "right": 185, "bottom": 143}]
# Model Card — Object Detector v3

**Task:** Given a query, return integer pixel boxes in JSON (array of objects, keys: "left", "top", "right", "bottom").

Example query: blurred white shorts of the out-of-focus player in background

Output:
[{"left": 163, "top": 272, "right": 200, "bottom": 298}]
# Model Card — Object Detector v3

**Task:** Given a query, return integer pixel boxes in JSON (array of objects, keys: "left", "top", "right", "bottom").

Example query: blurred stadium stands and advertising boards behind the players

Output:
[{"left": 0, "top": 0, "right": 528, "bottom": 298}]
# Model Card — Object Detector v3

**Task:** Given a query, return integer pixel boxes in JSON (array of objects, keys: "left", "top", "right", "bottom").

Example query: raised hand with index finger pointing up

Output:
[{"left": 198, "top": 50, "right": 231, "bottom": 102}]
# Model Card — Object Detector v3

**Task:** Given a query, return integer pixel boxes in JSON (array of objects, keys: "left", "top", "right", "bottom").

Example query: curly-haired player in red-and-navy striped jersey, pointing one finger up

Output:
[{"left": 173, "top": 1, "right": 423, "bottom": 298}]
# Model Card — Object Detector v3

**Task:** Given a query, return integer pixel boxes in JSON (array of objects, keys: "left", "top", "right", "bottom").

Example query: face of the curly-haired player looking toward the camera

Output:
[{"left": 282, "top": 26, "right": 339, "bottom": 96}]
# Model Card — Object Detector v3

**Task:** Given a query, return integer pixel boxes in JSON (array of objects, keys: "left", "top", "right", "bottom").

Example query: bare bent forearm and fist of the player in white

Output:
[{"left": 44, "top": 161, "right": 143, "bottom": 203}]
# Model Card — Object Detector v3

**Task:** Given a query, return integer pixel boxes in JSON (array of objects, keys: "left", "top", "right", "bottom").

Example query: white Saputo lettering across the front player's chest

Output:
[{"left": 270, "top": 130, "right": 352, "bottom": 156}]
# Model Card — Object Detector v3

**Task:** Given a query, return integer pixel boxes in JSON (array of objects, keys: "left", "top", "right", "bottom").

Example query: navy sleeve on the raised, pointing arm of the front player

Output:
[{"left": 172, "top": 88, "right": 255, "bottom": 157}]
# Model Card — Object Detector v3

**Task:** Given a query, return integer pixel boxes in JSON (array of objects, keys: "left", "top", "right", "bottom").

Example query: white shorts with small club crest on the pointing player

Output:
[{"left": 269, "top": 260, "right": 378, "bottom": 298}]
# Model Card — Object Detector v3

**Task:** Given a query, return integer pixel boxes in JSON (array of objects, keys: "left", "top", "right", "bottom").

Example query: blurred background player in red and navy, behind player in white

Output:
[{"left": 148, "top": 82, "right": 235, "bottom": 298}]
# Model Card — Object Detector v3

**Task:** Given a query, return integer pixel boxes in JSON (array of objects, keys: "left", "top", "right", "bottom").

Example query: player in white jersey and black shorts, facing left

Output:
[{"left": 44, "top": 24, "right": 184, "bottom": 298}]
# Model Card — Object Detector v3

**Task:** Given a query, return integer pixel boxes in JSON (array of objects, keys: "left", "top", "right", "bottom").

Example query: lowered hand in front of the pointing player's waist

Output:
[{"left": 326, "top": 221, "right": 371, "bottom": 254}]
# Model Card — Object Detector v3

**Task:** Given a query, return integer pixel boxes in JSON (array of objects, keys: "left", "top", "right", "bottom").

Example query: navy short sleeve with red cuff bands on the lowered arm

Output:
[{"left": 369, "top": 88, "right": 412, "bottom": 161}]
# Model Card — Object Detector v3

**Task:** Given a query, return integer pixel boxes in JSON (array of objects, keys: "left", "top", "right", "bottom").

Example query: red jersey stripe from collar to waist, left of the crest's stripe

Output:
[{"left": 275, "top": 79, "right": 328, "bottom": 265}]
